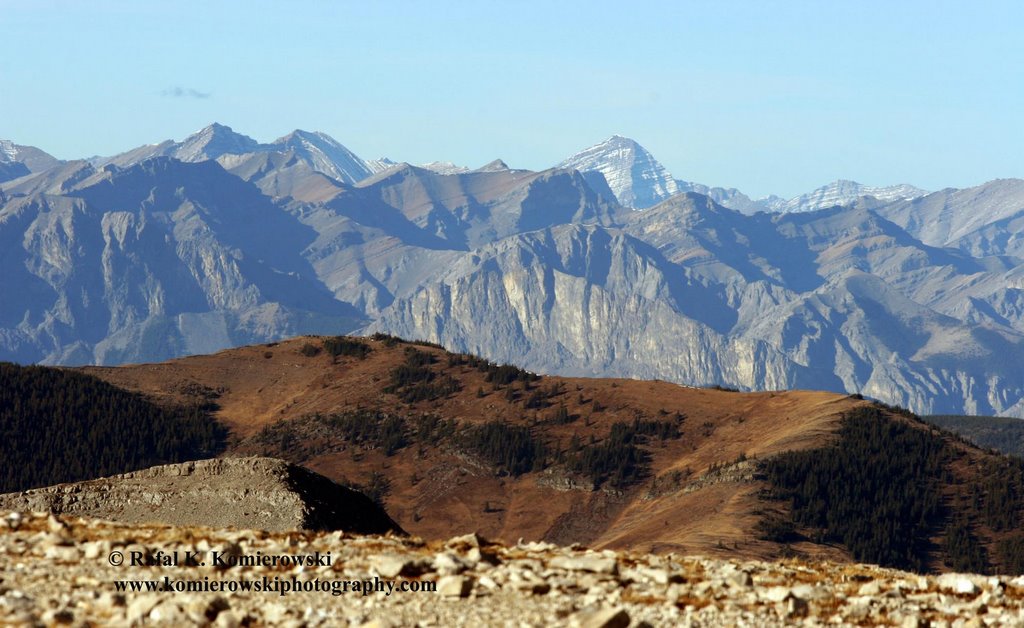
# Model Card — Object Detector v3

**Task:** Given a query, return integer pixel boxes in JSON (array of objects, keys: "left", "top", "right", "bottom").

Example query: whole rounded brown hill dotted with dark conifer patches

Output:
[{"left": 84, "top": 336, "right": 1024, "bottom": 571}]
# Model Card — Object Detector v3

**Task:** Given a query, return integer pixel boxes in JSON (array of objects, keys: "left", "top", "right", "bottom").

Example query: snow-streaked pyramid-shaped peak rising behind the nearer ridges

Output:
[{"left": 558, "top": 135, "right": 679, "bottom": 209}]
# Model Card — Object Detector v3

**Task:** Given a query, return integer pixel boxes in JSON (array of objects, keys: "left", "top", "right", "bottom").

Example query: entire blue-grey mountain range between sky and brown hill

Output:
[{"left": 0, "top": 124, "right": 1024, "bottom": 417}]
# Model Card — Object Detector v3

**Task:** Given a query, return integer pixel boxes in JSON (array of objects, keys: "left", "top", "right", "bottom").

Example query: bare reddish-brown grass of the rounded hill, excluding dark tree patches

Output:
[{"left": 77, "top": 337, "right": 865, "bottom": 556}]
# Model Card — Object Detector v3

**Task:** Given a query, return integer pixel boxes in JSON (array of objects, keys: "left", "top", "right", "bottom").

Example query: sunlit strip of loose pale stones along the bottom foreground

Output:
[{"left": 0, "top": 512, "right": 1024, "bottom": 628}]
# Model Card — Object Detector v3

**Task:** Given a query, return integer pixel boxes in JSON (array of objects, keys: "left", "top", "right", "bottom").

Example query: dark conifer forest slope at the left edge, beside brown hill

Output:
[{"left": 0, "top": 363, "right": 224, "bottom": 493}]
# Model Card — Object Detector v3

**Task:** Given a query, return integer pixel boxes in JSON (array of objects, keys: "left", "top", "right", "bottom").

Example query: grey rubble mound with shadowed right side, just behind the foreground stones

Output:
[{"left": 0, "top": 458, "right": 401, "bottom": 534}]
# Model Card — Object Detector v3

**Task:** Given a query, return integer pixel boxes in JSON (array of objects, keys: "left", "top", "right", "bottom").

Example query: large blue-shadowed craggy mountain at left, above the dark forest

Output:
[{"left": 0, "top": 157, "right": 360, "bottom": 364}]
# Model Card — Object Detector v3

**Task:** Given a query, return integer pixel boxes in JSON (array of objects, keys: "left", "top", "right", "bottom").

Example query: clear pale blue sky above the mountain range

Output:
[{"left": 0, "top": 0, "right": 1024, "bottom": 197}]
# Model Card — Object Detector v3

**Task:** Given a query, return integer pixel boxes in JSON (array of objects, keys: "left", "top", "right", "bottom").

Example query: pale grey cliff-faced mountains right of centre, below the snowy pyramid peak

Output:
[{"left": 371, "top": 195, "right": 1024, "bottom": 416}]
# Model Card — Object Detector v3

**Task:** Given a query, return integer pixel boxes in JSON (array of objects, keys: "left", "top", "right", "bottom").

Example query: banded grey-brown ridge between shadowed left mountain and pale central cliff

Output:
[{"left": 278, "top": 164, "right": 623, "bottom": 316}]
